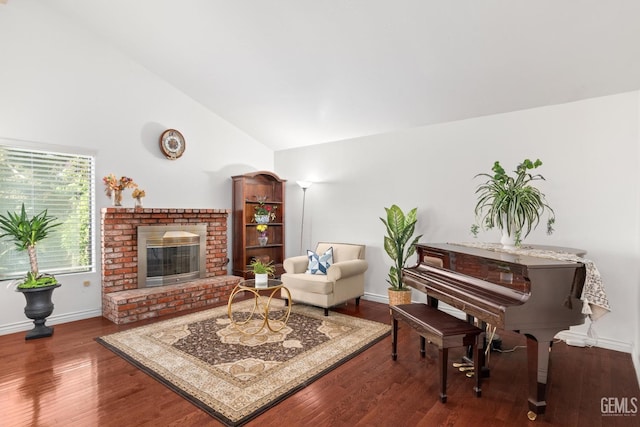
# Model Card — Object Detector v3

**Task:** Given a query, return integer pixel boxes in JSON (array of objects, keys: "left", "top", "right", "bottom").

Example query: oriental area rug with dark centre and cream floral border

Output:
[{"left": 96, "top": 299, "right": 390, "bottom": 426}]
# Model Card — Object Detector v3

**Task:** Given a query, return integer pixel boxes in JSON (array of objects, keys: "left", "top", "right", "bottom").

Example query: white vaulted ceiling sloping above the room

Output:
[{"left": 42, "top": 0, "right": 640, "bottom": 150}]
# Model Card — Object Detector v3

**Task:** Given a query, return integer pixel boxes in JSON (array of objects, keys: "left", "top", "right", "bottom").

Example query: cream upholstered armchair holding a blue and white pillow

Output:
[{"left": 280, "top": 242, "right": 369, "bottom": 316}]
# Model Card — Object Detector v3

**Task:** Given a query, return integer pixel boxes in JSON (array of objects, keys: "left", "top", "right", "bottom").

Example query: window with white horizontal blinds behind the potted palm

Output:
[{"left": 0, "top": 143, "right": 95, "bottom": 280}]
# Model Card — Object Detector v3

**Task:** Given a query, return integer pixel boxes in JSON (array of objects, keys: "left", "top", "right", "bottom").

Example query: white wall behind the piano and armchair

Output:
[{"left": 275, "top": 92, "right": 640, "bottom": 366}]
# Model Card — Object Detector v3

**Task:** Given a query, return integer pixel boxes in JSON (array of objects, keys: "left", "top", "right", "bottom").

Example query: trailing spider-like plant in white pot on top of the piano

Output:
[{"left": 471, "top": 159, "right": 555, "bottom": 247}]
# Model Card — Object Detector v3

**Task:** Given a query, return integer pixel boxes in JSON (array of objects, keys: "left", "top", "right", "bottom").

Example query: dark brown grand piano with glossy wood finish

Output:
[{"left": 402, "top": 243, "right": 585, "bottom": 420}]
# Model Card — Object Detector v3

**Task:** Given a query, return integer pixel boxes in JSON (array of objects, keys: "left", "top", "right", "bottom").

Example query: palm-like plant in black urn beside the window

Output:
[{"left": 0, "top": 203, "right": 60, "bottom": 339}]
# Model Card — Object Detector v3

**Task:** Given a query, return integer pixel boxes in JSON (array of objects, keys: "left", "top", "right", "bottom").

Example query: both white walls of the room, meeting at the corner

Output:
[{"left": 0, "top": 0, "right": 640, "bottom": 382}]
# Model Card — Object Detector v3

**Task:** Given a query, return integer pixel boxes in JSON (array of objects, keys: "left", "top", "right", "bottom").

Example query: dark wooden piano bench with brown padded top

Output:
[{"left": 390, "top": 304, "right": 482, "bottom": 403}]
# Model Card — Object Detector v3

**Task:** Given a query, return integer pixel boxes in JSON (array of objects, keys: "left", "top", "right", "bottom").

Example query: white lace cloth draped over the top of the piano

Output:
[{"left": 451, "top": 242, "right": 611, "bottom": 321}]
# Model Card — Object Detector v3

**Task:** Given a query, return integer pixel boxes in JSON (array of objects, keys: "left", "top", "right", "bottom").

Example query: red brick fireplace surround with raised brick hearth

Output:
[{"left": 101, "top": 208, "right": 241, "bottom": 324}]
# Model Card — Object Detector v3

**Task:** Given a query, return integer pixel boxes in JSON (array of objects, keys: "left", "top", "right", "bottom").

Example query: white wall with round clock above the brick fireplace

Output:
[{"left": 0, "top": 1, "right": 273, "bottom": 334}]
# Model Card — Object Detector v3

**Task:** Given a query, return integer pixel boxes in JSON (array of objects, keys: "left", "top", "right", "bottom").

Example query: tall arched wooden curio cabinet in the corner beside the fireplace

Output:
[{"left": 232, "top": 171, "right": 286, "bottom": 279}]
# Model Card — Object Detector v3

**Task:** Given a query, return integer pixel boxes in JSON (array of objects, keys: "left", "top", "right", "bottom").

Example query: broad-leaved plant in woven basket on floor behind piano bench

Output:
[{"left": 380, "top": 205, "right": 422, "bottom": 305}]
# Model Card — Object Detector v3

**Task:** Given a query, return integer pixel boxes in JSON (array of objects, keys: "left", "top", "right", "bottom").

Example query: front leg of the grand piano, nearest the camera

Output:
[{"left": 526, "top": 335, "right": 551, "bottom": 421}]
